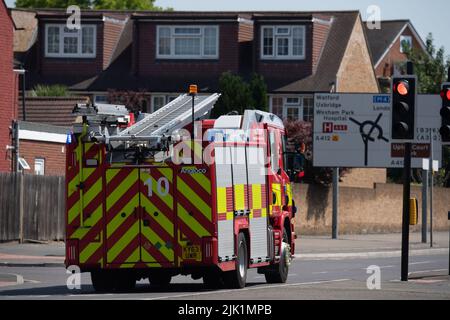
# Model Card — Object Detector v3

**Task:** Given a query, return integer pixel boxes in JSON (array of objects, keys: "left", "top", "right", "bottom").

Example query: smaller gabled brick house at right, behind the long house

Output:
[{"left": 366, "top": 20, "right": 427, "bottom": 91}]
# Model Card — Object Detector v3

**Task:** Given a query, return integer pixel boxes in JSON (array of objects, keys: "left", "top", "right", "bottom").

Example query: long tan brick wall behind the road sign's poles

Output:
[{"left": 293, "top": 184, "right": 450, "bottom": 235}]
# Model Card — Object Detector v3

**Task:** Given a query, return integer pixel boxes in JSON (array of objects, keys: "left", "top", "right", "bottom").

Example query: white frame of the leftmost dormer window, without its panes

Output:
[{"left": 44, "top": 24, "right": 97, "bottom": 58}]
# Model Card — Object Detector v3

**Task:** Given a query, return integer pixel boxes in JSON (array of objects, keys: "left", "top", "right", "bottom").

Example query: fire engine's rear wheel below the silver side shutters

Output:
[{"left": 224, "top": 233, "right": 248, "bottom": 289}]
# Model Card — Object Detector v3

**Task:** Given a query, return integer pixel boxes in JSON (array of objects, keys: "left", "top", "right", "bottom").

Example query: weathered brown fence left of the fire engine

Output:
[{"left": 0, "top": 173, "right": 65, "bottom": 241}]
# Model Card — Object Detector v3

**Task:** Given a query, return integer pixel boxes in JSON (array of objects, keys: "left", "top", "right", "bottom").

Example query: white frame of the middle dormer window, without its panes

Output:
[{"left": 156, "top": 25, "right": 220, "bottom": 60}]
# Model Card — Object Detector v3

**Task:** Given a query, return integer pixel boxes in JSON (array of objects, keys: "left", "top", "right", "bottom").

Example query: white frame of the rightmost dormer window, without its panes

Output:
[{"left": 260, "top": 25, "right": 306, "bottom": 60}]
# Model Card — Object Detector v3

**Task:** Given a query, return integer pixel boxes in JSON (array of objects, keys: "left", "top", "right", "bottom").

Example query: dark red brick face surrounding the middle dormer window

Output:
[{"left": 134, "top": 22, "right": 239, "bottom": 80}]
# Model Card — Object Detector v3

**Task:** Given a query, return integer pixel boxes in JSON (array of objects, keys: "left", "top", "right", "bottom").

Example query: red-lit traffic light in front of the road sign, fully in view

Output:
[{"left": 391, "top": 76, "right": 417, "bottom": 141}]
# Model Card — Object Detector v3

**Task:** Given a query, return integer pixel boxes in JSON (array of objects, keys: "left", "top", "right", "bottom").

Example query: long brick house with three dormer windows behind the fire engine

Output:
[{"left": 14, "top": 10, "right": 385, "bottom": 184}]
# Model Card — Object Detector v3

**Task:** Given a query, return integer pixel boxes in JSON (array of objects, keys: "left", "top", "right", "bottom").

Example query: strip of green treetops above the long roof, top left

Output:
[{"left": 15, "top": 0, "right": 163, "bottom": 10}]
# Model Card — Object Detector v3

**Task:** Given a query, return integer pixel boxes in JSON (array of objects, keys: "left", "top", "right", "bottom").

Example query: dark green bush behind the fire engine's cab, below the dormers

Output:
[{"left": 213, "top": 72, "right": 268, "bottom": 117}]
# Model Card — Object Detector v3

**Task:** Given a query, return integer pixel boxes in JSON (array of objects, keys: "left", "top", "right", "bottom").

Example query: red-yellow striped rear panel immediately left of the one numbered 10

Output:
[{"left": 105, "top": 167, "right": 141, "bottom": 267}]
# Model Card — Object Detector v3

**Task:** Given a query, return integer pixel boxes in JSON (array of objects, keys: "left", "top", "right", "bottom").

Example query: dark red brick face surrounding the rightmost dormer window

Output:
[{"left": 254, "top": 22, "right": 313, "bottom": 90}]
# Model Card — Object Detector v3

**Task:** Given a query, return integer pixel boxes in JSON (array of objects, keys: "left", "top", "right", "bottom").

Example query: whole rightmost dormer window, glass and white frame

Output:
[{"left": 261, "top": 26, "right": 305, "bottom": 60}]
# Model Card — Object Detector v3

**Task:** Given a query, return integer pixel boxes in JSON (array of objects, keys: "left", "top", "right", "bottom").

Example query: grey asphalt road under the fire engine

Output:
[{"left": 0, "top": 254, "right": 450, "bottom": 300}]
